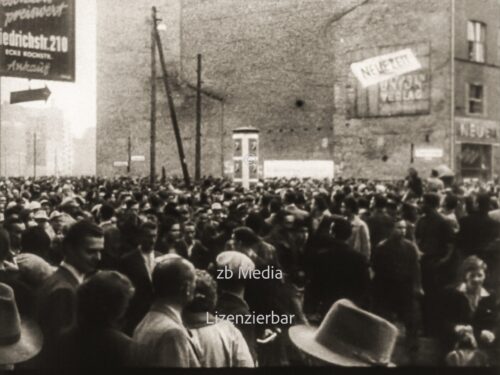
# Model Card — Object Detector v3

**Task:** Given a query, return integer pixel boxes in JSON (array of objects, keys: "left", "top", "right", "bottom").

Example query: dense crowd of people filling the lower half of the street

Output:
[{"left": 0, "top": 170, "right": 500, "bottom": 368}]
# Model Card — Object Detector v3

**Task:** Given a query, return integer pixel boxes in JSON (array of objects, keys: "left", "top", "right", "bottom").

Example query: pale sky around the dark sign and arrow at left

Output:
[{"left": 1, "top": 0, "right": 97, "bottom": 137}]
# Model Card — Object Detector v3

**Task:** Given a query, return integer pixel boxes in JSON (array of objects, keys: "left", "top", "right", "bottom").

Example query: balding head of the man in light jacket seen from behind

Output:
[{"left": 152, "top": 257, "right": 195, "bottom": 306}]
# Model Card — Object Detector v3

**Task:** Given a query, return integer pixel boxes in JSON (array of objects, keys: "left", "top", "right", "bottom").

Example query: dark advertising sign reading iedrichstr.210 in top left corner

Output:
[{"left": 0, "top": 0, "right": 75, "bottom": 82}]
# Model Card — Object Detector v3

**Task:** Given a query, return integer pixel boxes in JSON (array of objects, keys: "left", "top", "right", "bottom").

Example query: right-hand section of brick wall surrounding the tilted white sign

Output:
[{"left": 327, "top": 0, "right": 451, "bottom": 179}]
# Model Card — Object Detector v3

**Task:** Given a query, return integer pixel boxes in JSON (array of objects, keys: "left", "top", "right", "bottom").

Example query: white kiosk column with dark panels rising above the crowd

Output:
[{"left": 233, "top": 127, "right": 259, "bottom": 189}]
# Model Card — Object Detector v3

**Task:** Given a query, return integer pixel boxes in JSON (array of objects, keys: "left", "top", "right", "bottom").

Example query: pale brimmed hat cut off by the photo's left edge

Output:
[{"left": 0, "top": 283, "right": 43, "bottom": 370}]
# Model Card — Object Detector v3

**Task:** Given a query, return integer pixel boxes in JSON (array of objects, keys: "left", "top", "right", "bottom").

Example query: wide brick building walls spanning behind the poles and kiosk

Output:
[{"left": 97, "top": 0, "right": 500, "bottom": 182}]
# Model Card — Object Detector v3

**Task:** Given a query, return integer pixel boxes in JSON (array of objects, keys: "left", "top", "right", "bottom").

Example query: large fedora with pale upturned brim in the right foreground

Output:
[{"left": 288, "top": 299, "right": 398, "bottom": 367}]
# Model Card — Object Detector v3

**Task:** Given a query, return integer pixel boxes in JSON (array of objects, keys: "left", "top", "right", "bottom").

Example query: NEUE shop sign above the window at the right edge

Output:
[{"left": 455, "top": 118, "right": 500, "bottom": 143}]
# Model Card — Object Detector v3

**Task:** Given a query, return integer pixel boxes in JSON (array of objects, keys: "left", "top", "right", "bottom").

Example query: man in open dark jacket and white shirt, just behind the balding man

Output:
[{"left": 118, "top": 221, "right": 160, "bottom": 335}]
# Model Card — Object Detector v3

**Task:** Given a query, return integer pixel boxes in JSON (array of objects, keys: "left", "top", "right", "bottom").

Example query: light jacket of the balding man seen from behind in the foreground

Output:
[{"left": 133, "top": 302, "right": 200, "bottom": 368}]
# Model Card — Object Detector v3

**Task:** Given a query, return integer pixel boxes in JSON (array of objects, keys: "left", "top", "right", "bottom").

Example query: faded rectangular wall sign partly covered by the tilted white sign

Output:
[{"left": 346, "top": 43, "right": 431, "bottom": 118}]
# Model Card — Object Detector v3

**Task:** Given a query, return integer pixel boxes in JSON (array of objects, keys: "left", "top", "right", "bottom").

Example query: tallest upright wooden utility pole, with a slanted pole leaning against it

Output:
[{"left": 149, "top": 7, "right": 158, "bottom": 187}]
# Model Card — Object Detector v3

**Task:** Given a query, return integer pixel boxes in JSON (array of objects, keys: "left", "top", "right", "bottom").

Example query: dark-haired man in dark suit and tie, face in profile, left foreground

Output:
[{"left": 37, "top": 220, "right": 104, "bottom": 368}]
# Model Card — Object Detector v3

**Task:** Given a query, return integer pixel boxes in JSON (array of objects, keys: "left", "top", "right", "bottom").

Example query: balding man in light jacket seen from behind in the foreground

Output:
[{"left": 134, "top": 256, "right": 200, "bottom": 368}]
